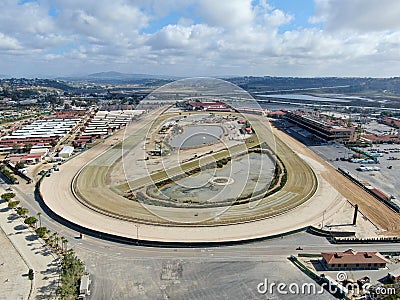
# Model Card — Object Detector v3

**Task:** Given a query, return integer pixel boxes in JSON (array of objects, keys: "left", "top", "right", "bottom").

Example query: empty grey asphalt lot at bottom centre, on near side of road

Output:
[{"left": 82, "top": 259, "right": 332, "bottom": 300}]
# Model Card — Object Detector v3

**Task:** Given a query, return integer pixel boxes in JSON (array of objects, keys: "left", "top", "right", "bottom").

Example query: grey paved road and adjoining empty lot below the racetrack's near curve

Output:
[{"left": 7, "top": 179, "right": 398, "bottom": 300}]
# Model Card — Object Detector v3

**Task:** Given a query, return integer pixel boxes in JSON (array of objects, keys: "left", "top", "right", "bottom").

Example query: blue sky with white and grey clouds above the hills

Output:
[{"left": 0, "top": 0, "right": 400, "bottom": 77}]
